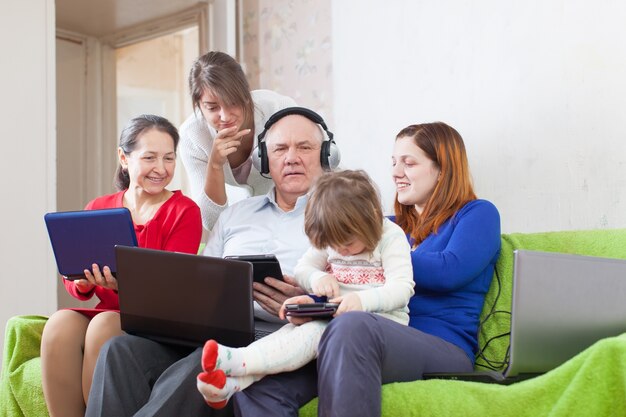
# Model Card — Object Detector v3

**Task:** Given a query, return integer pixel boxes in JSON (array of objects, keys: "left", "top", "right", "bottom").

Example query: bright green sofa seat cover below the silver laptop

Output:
[{"left": 300, "top": 334, "right": 626, "bottom": 417}]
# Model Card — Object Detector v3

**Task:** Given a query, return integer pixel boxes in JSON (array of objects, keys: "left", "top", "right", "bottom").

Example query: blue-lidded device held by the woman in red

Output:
[{"left": 44, "top": 207, "right": 137, "bottom": 280}]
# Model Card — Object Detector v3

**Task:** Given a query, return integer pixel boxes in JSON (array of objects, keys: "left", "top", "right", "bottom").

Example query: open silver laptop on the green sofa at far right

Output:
[{"left": 424, "top": 250, "right": 626, "bottom": 384}]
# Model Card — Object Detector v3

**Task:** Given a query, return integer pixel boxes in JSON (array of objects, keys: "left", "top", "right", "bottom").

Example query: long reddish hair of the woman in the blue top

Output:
[{"left": 394, "top": 122, "right": 476, "bottom": 247}]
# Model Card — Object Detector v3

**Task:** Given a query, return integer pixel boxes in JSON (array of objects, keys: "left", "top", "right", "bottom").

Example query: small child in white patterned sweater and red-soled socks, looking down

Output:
[{"left": 198, "top": 171, "right": 414, "bottom": 408}]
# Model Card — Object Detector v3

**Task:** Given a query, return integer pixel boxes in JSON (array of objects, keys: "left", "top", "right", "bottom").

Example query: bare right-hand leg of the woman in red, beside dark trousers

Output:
[{"left": 82, "top": 311, "right": 123, "bottom": 404}]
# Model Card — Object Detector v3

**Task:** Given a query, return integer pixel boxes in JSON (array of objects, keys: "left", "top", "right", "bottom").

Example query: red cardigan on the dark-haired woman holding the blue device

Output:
[{"left": 64, "top": 190, "right": 202, "bottom": 317}]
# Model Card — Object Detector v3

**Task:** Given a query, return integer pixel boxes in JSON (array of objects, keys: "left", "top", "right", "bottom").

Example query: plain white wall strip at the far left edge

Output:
[{"left": 0, "top": 0, "right": 56, "bottom": 358}]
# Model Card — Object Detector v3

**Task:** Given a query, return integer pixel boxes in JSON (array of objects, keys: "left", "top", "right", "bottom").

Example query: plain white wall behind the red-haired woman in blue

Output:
[{"left": 332, "top": 0, "right": 626, "bottom": 232}]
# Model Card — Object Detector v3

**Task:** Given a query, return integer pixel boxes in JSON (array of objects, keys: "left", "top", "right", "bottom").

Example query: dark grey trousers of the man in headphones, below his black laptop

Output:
[{"left": 85, "top": 335, "right": 232, "bottom": 417}]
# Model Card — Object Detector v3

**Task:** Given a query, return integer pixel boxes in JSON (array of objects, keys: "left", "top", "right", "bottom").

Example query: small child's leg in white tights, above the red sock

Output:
[{"left": 241, "top": 320, "right": 328, "bottom": 376}]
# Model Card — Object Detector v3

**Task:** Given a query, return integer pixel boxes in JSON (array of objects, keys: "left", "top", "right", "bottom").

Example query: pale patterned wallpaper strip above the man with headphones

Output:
[{"left": 242, "top": 0, "right": 333, "bottom": 123}]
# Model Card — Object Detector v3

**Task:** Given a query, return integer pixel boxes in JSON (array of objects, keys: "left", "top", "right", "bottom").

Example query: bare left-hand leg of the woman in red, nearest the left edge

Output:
[{"left": 41, "top": 310, "right": 89, "bottom": 417}]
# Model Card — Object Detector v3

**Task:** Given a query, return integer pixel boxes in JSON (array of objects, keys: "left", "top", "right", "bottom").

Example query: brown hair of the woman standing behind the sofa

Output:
[{"left": 189, "top": 51, "right": 254, "bottom": 120}]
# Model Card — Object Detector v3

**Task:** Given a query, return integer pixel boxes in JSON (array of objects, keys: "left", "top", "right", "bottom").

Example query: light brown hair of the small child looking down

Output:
[{"left": 304, "top": 170, "right": 383, "bottom": 252}]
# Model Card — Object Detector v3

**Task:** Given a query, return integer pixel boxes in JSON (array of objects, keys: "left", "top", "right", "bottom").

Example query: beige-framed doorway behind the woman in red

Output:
[{"left": 56, "top": 12, "right": 202, "bottom": 308}]
